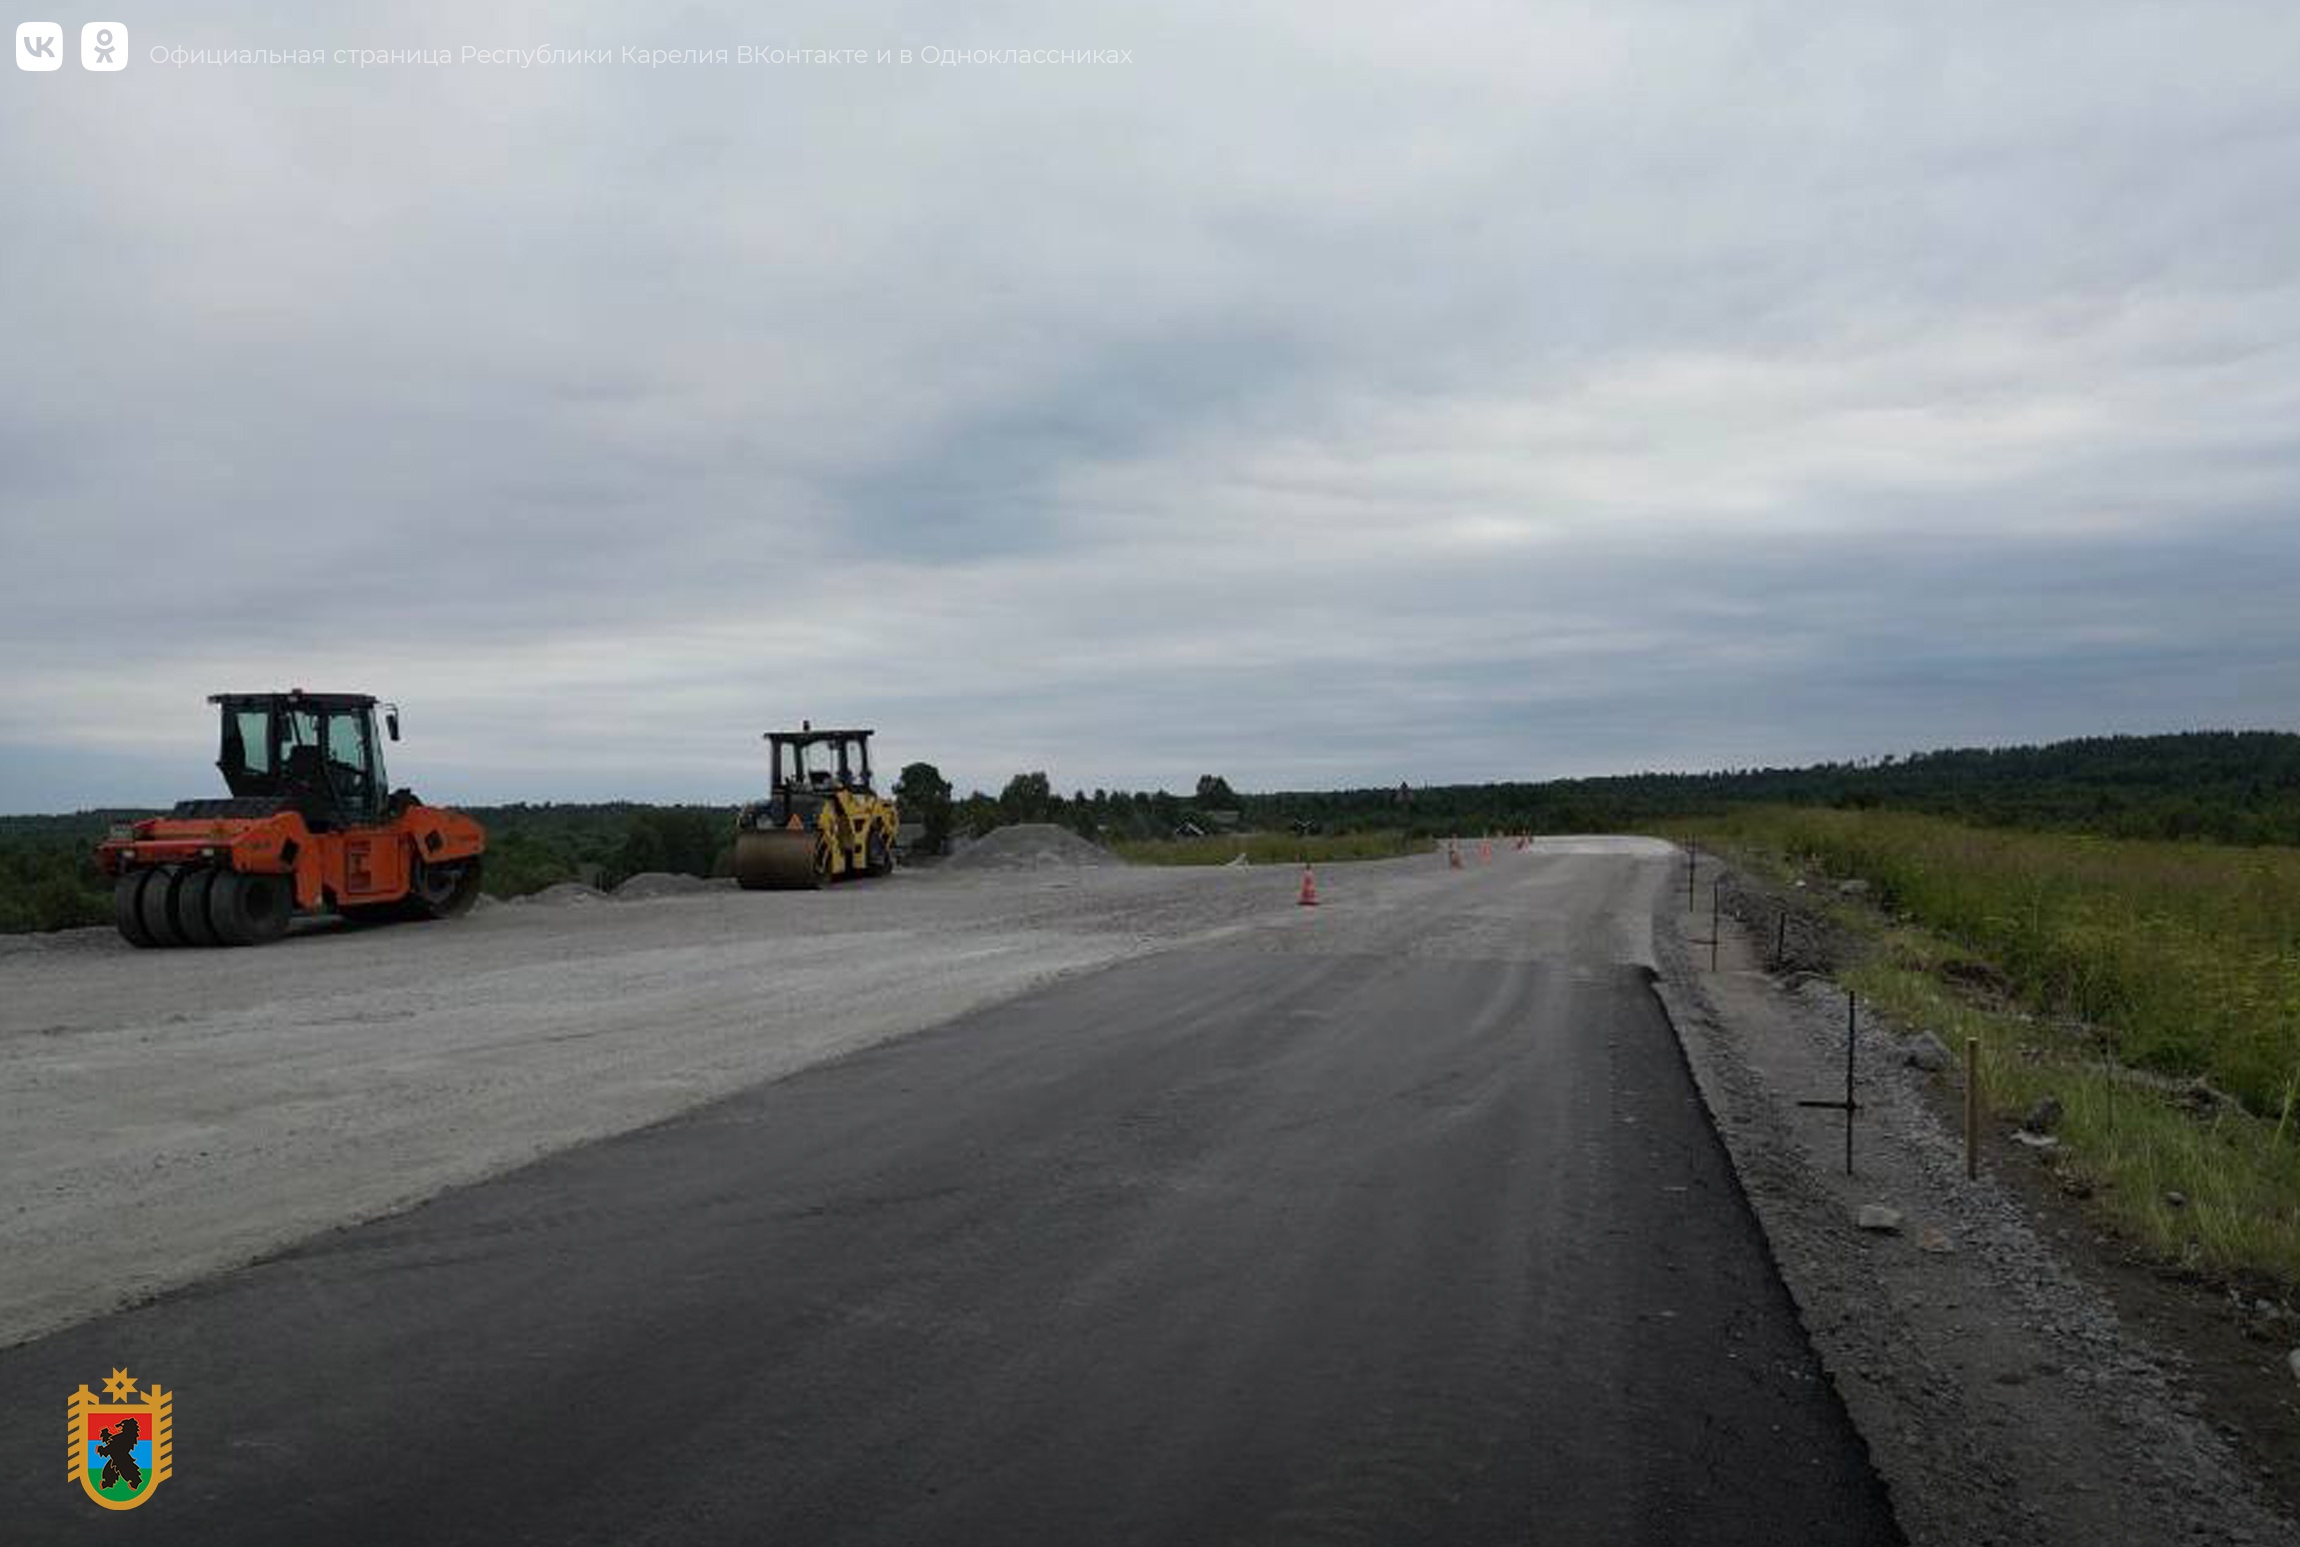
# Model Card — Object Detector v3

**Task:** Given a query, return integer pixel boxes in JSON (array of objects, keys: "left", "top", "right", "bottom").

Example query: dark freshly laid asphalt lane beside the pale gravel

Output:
[{"left": 0, "top": 860, "right": 1898, "bottom": 1547}]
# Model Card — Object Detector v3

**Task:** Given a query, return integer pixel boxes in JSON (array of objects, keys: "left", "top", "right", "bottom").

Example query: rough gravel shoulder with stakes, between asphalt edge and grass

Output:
[{"left": 1654, "top": 845, "right": 2300, "bottom": 1547}]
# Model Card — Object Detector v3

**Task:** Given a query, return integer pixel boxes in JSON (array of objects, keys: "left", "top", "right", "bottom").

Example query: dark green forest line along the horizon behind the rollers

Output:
[{"left": 13, "top": 731, "right": 2300, "bottom": 933}]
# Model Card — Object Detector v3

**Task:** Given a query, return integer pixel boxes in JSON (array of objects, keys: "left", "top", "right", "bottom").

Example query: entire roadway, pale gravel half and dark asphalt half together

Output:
[{"left": 0, "top": 844, "right": 1898, "bottom": 1545}]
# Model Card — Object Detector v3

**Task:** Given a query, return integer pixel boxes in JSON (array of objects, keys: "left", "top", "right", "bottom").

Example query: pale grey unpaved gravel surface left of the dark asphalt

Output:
[{"left": 0, "top": 839, "right": 1661, "bottom": 1345}]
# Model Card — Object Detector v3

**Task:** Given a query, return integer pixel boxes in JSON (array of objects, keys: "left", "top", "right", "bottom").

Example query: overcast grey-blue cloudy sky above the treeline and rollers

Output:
[{"left": 0, "top": 0, "right": 2300, "bottom": 811}]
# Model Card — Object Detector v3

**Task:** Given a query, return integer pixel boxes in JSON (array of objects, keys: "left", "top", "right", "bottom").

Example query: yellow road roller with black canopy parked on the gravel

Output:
[{"left": 734, "top": 719, "right": 899, "bottom": 892}]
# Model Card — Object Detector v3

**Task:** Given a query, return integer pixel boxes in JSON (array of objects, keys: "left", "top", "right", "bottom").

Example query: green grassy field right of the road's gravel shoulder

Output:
[{"left": 1679, "top": 809, "right": 2300, "bottom": 1285}]
